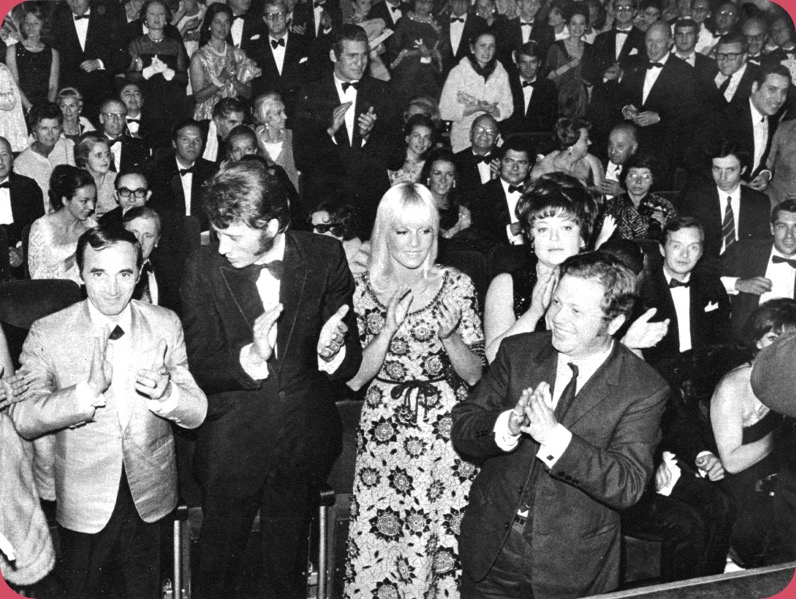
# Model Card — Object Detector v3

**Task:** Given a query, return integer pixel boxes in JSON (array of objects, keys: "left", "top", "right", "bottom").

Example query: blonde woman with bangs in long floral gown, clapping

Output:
[{"left": 345, "top": 183, "right": 484, "bottom": 599}]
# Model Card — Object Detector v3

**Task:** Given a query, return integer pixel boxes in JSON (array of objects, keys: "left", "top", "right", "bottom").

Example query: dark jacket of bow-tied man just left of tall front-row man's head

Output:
[{"left": 149, "top": 154, "right": 218, "bottom": 231}]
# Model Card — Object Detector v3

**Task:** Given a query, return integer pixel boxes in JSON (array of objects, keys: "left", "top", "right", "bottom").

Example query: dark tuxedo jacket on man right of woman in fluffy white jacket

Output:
[{"left": 500, "top": 72, "right": 558, "bottom": 136}]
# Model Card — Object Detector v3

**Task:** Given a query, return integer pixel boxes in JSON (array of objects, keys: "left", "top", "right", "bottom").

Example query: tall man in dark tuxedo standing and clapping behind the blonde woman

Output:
[{"left": 293, "top": 25, "right": 399, "bottom": 239}]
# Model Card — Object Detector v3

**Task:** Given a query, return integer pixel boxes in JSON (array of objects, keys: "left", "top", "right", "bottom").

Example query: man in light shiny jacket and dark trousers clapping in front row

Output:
[{"left": 12, "top": 227, "right": 207, "bottom": 599}]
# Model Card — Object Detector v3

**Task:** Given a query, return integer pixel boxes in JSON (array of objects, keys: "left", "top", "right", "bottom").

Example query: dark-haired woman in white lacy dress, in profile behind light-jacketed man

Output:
[{"left": 28, "top": 164, "right": 97, "bottom": 284}]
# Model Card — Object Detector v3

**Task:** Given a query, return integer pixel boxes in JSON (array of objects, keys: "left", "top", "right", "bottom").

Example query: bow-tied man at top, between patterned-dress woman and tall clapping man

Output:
[{"left": 249, "top": 0, "right": 310, "bottom": 118}]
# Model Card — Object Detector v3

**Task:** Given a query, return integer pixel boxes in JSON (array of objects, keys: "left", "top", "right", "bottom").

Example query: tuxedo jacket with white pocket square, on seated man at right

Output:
[{"left": 639, "top": 267, "right": 730, "bottom": 365}]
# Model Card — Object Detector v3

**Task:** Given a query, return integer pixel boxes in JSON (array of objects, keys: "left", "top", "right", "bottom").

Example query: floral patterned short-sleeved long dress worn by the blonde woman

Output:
[{"left": 345, "top": 267, "right": 484, "bottom": 599}]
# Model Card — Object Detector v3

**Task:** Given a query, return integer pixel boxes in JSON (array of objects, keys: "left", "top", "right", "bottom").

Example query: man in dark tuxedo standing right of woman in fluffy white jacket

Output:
[{"left": 500, "top": 41, "right": 558, "bottom": 137}]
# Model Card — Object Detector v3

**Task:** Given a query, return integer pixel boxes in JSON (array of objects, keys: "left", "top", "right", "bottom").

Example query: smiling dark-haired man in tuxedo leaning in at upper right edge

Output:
[{"left": 718, "top": 64, "right": 791, "bottom": 191}]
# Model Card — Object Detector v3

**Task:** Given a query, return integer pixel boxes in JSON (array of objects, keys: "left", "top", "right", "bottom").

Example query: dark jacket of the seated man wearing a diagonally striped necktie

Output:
[{"left": 680, "top": 185, "right": 771, "bottom": 261}]
